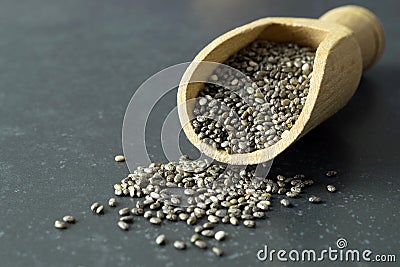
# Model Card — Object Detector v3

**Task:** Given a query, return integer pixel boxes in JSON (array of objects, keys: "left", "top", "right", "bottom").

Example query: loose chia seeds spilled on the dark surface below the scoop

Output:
[{"left": 54, "top": 156, "right": 337, "bottom": 256}]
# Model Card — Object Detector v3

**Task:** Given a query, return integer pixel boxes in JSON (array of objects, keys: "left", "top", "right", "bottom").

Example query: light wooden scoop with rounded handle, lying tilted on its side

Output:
[{"left": 178, "top": 6, "right": 384, "bottom": 165}]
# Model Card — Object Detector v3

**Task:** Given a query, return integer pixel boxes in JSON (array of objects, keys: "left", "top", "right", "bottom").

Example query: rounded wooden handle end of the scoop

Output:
[{"left": 319, "top": 5, "right": 385, "bottom": 70}]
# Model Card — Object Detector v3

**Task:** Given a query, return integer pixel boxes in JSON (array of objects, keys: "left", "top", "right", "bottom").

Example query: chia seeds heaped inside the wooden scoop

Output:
[{"left": 191, "top": 41, "right": 315, "bottom": 154}]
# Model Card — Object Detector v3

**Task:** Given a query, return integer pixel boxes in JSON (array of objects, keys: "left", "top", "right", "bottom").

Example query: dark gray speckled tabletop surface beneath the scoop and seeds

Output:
[{"left": 0, "top": 0, "right": 400, "bottom": 266}]
